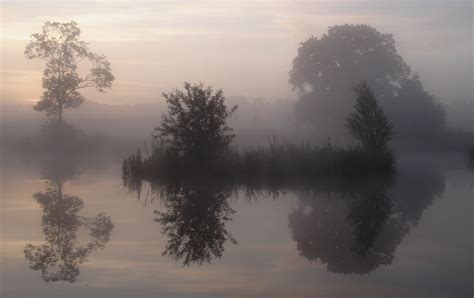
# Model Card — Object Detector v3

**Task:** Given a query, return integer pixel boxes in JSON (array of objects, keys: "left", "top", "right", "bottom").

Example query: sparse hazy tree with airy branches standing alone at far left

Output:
[{"left": 25, "top": 21, "right": 114, "bottom": 122}]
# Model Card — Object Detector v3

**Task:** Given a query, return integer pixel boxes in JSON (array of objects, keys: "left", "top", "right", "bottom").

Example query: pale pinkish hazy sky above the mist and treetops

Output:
[{"left": 0, "top": 0, "right": 473, "bottom": 103}]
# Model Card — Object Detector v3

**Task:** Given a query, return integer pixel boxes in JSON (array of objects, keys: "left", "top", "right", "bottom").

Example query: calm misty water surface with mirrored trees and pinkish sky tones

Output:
[{"left": 0, "top": 154, "right": 474, "bottom": 297}]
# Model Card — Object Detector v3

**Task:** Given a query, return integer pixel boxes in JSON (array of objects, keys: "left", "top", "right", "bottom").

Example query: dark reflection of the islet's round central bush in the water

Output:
[{"left": 155, "top": 184, "right": 236, "bottom": 265}]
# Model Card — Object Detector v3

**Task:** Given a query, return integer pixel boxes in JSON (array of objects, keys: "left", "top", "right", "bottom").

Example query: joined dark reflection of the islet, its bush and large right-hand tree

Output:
[{"left": 124, "top": 163, "right": 444, "bottom": 274}]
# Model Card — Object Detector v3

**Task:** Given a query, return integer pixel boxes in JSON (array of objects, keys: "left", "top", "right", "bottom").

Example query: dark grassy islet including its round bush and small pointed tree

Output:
[{"left": 122, "top": 82, "right": 395, "bottom": 182}]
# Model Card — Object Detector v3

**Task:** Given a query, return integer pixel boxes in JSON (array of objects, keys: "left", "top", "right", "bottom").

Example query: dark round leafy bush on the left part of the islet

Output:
[{"left": 155, "top": 82, "right": 237, "bottom": 162}]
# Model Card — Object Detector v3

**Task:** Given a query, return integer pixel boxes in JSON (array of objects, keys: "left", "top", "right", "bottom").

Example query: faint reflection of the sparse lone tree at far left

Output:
[{"left": 24, "top": 158, "right": 114, "bottom": 283}]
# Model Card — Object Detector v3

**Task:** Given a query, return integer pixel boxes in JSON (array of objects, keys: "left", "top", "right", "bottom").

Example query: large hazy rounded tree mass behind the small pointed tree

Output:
[{"left": 289, "top": 25, "right": 444, "bottom": 135}]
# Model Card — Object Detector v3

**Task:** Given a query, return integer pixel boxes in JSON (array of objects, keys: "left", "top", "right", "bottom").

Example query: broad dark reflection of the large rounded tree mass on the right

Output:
[{"left": 289, "top": 165, "right": 444, "bottom": 274}]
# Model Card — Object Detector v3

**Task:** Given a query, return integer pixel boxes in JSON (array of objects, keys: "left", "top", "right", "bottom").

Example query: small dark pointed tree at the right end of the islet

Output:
[{"left": 346, "top": 82, "right": 394, "bottom": 154}]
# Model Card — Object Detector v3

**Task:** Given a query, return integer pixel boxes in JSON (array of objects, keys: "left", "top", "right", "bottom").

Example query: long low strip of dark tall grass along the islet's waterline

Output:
[{"left": 122, "top": 137, "right": 395, "bottom": 183}]
